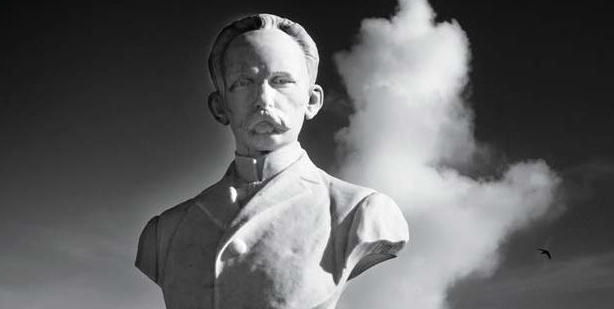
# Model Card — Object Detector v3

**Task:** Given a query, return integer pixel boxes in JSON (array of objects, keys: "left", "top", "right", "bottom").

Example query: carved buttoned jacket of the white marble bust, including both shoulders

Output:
[{"left": 136, "top": 154, "right": 408, "bottom": 309}]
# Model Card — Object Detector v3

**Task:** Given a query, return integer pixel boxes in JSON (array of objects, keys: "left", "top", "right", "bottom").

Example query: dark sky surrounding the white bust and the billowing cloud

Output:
[{"left": 0, "top": 0, "right": 614, "bottom": 309}]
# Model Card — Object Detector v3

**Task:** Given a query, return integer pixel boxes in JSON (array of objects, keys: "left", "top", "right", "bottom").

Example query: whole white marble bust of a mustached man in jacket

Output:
[{"left": 136, "top": 14, "right": 408, "bottom": 309}]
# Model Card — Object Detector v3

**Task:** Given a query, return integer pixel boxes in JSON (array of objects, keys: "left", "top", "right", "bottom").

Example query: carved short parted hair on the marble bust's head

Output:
[{"left": 209, "top": 14, "right": 320, "bottom": 92}]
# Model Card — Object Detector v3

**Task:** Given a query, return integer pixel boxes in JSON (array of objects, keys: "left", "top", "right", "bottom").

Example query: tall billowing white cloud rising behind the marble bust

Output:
[{"left": 335, "top": 0, "right": 559, "bottom": 309}]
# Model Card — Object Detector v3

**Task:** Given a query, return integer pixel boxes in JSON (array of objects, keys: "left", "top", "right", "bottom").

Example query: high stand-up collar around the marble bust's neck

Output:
[{"left": 234, "top": 141, "right": 305, "bottom": 182}]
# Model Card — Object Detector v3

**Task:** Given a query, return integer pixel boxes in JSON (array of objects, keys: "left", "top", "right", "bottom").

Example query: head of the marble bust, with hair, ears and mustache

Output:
[{"left": 209, "top": 14, "right": 324, "bottom": 156}]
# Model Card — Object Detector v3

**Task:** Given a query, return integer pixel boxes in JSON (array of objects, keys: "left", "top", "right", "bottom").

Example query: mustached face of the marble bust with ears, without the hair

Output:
[{"left": 212, "top": 29, "right": 322, "bottom": 156}]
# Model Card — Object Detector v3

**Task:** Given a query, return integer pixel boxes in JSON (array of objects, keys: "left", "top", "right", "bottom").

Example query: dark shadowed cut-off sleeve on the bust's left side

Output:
[{"left": 134, "top": 216, "right": 159, "bottom": 283}]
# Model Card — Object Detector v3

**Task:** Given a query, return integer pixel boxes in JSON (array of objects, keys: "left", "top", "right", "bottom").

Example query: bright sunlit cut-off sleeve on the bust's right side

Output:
[{"left": 344, "top": 193, "right": 409, "bottom": 280}]
